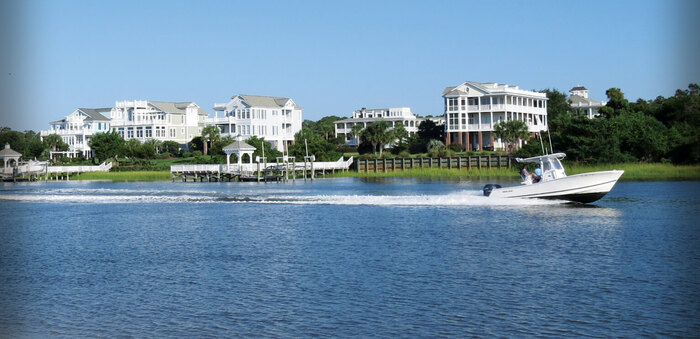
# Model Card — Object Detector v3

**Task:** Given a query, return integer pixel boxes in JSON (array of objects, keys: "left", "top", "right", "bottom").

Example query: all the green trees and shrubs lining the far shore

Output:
[{"left": 0, "top": 84, "right": 700, "bottom": 164}]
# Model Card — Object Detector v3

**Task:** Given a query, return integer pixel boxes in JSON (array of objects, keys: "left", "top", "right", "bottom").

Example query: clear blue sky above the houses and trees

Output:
[{"left": 0, "top": 0, "right": 700, "bottom": 131}]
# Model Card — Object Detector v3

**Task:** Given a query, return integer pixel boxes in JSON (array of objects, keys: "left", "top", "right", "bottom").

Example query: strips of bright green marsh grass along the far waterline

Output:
[{"left": 58, "top": 163, "right": 700, "bottom": 182}]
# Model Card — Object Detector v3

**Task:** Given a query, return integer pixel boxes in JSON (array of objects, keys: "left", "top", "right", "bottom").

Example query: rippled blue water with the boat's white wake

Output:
[{"left": 0, "top": 178, "right": 700, "bottom": 338}]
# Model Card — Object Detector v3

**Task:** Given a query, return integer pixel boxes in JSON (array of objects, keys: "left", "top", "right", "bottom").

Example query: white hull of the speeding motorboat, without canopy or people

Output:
[{"left": 489, "top": 170, "right": 624, "bottom": 203}]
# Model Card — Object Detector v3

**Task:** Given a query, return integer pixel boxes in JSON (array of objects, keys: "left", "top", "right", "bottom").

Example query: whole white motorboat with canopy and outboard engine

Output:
[{"left": 484, "top": 153, "right": 625, "bottom": 203}]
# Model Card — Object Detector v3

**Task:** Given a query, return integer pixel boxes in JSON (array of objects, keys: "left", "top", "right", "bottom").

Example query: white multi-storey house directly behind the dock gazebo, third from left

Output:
[{"left": 207, "top": 94, "right": 302, "bottom": 152}]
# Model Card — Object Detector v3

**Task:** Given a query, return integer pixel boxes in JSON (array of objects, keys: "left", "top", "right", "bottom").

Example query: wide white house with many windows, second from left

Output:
[{"left": 110, "top": 100, "right": 209, "bottom": 145}]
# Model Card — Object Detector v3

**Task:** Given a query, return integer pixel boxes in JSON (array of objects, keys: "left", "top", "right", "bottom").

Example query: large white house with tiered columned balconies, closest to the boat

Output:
[{"left": 442, "top": 81, "right": 547, "bottom": 150}]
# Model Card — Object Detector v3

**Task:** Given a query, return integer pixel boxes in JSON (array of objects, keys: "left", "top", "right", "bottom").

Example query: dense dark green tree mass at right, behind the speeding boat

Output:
[{"left": 516, "top": 84, "right": 700, "bottom": 164}]
